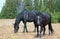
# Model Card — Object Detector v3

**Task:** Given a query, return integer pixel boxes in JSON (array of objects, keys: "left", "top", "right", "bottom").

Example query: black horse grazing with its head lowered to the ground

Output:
[{"left": 14, "top": 9, "right": 37, "bottom": 33}]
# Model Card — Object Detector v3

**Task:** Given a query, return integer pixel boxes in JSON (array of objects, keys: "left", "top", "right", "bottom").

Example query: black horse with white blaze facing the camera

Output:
[{"left": 35, "top": 12, "right": 53, "bottom": 37}]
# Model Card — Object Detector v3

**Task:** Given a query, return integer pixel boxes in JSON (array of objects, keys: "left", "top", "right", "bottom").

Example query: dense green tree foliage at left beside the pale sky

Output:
[{"left": 0, "top": 0, "right": 17, "bottom": 18}]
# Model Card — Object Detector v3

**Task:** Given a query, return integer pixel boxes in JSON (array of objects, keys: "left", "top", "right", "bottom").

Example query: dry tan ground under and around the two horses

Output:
[{"left": 0, "top": 19, "right": 60, "bottom": 39}]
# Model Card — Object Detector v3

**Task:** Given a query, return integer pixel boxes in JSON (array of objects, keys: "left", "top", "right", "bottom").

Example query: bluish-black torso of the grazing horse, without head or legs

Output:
[{"left": 22, "top": 11, "right": 35, "bottom": 22}]
